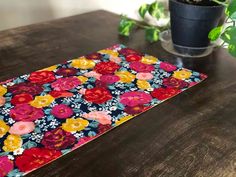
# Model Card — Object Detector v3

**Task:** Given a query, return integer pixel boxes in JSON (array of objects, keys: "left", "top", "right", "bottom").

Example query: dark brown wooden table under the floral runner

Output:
[{"left": 0, "top": 11, "right": 236, "bottom": 177}]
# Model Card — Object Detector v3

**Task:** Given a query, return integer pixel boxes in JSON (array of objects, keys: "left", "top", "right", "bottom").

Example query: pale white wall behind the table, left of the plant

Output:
[{"left": 0, "top": 0, "right": 160, "bottom": 30}]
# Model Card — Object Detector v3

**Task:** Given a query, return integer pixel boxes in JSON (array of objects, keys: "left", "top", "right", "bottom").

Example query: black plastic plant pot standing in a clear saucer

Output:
[{"left": 169, "top": 0, "right": 224, "bottom": 54}]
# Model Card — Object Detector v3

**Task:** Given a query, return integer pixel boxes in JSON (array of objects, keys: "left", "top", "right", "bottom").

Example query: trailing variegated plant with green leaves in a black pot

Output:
[{"left": 119, "top": 0, "right": 236, "bottom": 57}]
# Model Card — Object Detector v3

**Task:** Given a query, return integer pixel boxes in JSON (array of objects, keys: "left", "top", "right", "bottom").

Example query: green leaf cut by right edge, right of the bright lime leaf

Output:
[{"left": 221, "top": 26, "right": 236, "bottom": 45}]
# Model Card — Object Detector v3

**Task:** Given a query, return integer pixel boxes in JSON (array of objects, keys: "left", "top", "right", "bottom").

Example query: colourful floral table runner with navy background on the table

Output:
[{"left": 0, "top": 45, "right": 206, "bottom": 177}]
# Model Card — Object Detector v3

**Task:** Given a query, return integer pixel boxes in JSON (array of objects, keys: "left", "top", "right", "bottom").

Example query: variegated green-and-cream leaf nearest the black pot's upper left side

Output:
[{"left": 148, "top": 1, "right": 165, "bottom": 19}]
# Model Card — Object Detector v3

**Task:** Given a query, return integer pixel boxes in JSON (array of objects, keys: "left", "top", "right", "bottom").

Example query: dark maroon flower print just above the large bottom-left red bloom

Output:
[{"left": 41, "top": 128, "right": 76, "bottom": 150}]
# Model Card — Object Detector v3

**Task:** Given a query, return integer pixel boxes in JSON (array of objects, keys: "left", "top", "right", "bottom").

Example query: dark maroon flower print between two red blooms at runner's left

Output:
[{"left": 8, "top": 82, "right": 43, "bottom": 96}]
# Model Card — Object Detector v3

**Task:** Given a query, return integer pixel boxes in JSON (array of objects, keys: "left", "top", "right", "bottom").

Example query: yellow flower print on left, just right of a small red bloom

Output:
[{"left": 30, "top": 95, "right": 54, "bottom": 108}]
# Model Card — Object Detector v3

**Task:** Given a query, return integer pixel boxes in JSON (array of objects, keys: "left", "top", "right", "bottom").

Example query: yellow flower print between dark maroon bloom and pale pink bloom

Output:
[{"left": 62, "top": 118, "right": 89, "bottom": 132}]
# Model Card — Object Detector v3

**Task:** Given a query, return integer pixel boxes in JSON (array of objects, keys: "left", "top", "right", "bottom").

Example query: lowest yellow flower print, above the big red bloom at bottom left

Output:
[{"left": 2, "top": 135, "right": 22, "bottom": 152}]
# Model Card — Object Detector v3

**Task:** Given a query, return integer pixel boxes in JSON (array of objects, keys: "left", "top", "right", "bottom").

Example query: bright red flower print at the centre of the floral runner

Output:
[{"left": 84, "top": 88, "right": 112, "bottom": 104}]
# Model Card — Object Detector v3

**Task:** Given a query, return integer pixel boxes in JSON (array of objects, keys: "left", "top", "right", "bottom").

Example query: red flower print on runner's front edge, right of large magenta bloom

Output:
[{"left": 151, "top": 88, "right": 181, "bottom": 100}]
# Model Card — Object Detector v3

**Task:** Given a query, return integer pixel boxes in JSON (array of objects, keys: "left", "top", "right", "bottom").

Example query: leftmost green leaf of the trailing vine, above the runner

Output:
[{"left": 118, "top": 17, "right": 135, "bottom": 36}]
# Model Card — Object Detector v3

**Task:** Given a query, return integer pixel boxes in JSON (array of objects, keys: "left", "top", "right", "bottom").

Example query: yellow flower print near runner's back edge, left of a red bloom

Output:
[{"left": 71, "top": 57, "right": 96, "bottom": 69}]
